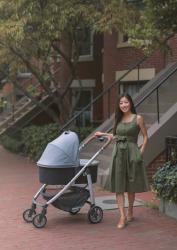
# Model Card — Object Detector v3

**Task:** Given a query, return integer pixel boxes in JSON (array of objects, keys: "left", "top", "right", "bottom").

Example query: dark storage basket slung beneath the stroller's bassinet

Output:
[{"left": 42, "top": 187, "right": 90, "bottom": 212}]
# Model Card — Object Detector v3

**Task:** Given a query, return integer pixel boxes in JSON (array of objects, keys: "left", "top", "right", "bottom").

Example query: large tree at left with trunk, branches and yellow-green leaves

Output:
[{"left": 0, "top": 0, "right": 139, "bottom": 124}]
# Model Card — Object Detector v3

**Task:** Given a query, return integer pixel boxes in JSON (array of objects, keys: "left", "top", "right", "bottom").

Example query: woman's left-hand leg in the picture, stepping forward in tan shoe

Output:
[{"left": 116, "top": 193, "right": 126, "bottom": 229}]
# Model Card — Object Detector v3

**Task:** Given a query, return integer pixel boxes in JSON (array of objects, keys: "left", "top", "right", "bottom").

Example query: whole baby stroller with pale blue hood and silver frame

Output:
[{"left": 23, "top": 131, "right": 110, "bottom": 228}]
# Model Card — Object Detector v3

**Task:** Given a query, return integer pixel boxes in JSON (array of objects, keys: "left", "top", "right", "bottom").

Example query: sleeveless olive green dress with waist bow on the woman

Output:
[{"left": 105, "top": 115, "right": 149, "bottom": 193}]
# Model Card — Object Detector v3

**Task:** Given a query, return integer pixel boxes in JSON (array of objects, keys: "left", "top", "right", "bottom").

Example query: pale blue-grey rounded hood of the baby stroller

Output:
[{"left": 37, "top": 131, "right": 79, "bottom": 168}]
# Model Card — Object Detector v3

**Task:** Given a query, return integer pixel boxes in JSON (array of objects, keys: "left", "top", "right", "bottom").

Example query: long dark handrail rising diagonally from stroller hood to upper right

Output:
[{"left": 59, "top": 56, "right": 147, "bottom": 133}]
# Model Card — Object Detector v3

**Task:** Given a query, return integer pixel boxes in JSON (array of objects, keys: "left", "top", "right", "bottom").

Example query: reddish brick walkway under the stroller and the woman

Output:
[{"left": 0, "top": 147, "right": 177, "bottom": 250}]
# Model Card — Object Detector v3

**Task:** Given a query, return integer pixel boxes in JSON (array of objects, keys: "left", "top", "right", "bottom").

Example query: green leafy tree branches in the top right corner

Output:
[{"left": 128, "top": 0, "right": 177, "bottom": 53}]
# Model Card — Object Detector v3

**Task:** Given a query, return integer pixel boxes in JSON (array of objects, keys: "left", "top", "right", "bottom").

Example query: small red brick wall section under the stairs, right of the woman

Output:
[{"left": 147, "top": 151, "right": 166, "bottom": 183}]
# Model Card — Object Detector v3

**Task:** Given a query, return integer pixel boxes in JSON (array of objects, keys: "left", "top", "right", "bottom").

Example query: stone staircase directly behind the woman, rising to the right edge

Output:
[{"left": 81, "top": 60, "right": 177, "bottom": 186}]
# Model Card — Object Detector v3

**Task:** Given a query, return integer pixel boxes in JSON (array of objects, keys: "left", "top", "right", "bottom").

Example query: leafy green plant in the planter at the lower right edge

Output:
[{"left": 152, "top": 162, "right": 177, "bottom": 203}]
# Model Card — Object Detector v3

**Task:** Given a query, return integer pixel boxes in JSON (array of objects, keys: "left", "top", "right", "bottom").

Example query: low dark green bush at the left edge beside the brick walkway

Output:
[{"left": 0, "top": 135, "right": 23, "bottom": 153}]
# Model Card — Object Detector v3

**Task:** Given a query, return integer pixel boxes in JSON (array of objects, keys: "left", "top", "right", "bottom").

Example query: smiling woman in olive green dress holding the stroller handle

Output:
[{"left": 95, "top": 94, "right": 149, "bottom": 229}]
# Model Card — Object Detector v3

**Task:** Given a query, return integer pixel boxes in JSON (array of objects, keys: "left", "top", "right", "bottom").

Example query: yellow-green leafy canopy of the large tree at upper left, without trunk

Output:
[{"left": 0, "top": 0, "right": 137, "bottom": 68}]
